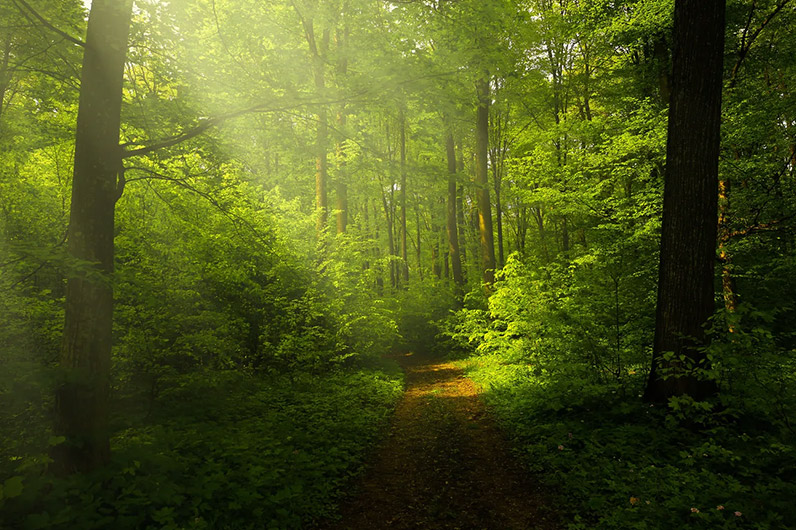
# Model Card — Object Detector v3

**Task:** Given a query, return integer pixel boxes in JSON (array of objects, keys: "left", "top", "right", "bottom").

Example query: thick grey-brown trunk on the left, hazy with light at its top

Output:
[{"left": 53, "top": 0, "right": 132, "bottom": 473}]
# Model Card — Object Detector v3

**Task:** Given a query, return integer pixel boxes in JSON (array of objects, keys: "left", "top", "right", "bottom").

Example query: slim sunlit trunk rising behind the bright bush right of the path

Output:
[{"left": 475, "top": 78, "right": 495, "bottom": 289}]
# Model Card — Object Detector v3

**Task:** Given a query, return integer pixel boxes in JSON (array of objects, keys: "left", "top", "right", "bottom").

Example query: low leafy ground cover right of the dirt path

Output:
[{"left": 459, "top": 354, "right": 796, "bottom": 530}]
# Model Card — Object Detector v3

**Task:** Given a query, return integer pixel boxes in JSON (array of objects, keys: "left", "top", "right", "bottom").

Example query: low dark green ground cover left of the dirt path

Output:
[{"left": 0, "top": 361, "right": 402, "bottom": 530}]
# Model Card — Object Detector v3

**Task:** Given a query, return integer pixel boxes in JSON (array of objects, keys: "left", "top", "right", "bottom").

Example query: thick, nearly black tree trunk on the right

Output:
[{"left": 644, "top": 0, "right": 725, "bottom": 401}]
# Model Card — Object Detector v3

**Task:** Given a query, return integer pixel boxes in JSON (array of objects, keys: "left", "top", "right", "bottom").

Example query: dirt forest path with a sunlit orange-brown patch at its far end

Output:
[{"left": 324, "top": 354, "right": 556, "bottom": 530}]
